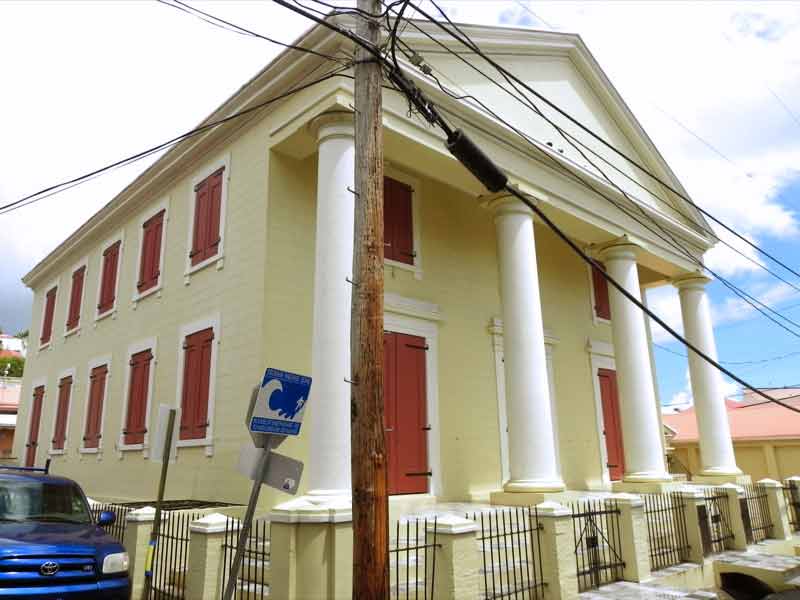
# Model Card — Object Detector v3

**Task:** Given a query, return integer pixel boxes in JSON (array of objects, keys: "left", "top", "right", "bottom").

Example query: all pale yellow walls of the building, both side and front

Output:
[{"left": 15, "top": 95, "right": 652, "bottom": 507}]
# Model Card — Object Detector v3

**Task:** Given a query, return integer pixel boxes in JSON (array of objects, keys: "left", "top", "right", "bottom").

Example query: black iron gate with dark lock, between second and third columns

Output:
[{"left": 572, "top": 500, "right": 625, "bottom": 592}]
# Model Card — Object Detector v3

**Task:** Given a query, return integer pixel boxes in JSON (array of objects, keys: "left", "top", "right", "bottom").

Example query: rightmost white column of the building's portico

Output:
[{"left": 674, "top": 273, "right": 742, "bottom": 476}]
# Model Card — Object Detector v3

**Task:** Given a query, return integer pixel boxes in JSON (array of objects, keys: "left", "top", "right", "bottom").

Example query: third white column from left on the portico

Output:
[{"left": 602, "top": 242, "right": 671, "bottom": 482}]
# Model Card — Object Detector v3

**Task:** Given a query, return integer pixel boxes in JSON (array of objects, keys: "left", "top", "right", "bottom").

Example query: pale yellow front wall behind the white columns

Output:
[{"left": 264, "top": 152, "right": 610, "bottom": 503}]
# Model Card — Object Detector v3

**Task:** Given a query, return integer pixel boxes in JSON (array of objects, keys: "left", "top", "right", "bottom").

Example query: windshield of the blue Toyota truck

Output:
[{"left": 0, "top": 479, "right": 92, "bottom": 523}]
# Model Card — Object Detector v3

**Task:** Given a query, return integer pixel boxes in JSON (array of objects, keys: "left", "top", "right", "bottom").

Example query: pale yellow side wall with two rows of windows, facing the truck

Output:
[{"left": 15, "top": 116, "right": 268, "bottom": 501}]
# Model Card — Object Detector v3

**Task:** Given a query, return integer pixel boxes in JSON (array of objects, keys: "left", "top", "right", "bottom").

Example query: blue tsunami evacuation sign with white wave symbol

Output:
[{"left": 250, "top": 369, "right": 311, "bottom": 435}]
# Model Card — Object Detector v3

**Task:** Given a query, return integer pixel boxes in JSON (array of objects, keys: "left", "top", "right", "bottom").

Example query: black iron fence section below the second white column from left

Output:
[{"left": 467, "top": 507, "right": 545, "bottom": 600}]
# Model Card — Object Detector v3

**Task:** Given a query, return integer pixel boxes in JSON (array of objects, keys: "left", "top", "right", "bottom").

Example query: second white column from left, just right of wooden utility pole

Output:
[{"left": 490, "top": 197, "right": 564, "bottom": 492}]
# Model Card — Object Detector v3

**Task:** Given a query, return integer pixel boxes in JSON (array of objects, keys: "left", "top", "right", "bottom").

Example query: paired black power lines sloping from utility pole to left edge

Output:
[{"left": 0, "top": 64, "right": 351, "bottom": 215}]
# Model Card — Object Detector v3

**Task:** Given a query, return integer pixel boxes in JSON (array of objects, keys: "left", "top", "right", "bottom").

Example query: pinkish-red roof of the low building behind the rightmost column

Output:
[{"left": 663, "top": 390, "right": 800, "bottom": 443}]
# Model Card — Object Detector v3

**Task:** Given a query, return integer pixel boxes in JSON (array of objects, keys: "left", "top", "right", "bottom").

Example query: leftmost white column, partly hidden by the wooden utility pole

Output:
[{"left": 306, "top": 112, "right": 355, "bottom": 496}]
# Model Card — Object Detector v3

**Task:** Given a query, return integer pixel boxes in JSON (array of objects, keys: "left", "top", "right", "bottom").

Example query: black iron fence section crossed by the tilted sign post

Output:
[{"left": 220, "top": 517, "right": 270, "bottom": 600}]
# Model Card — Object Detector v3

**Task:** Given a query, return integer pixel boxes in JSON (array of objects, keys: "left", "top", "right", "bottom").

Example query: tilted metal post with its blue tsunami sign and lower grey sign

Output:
[{"left": 222, "top": 369, "right": 311, "bottom": 600}]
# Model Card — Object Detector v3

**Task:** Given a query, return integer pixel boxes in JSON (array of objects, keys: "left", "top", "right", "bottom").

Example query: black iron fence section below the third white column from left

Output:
[{"left": 642, "top": 493, "right": 690, "bottom": 571}]
